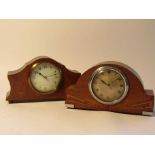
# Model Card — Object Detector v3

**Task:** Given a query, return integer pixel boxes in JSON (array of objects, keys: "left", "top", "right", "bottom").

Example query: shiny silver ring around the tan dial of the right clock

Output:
[{"left": 88, "top": 66, "right": 129, "bottom": 105}]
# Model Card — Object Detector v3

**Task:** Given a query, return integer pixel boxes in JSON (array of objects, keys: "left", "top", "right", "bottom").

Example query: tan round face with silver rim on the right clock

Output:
[{"left": 89, "top": 66, "right": 128, "bottom": 104}]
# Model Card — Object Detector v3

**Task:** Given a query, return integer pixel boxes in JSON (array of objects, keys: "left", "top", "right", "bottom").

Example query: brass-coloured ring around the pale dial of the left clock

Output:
[{"left": 28, "top": 62, "right": 62, "bottom": 95}]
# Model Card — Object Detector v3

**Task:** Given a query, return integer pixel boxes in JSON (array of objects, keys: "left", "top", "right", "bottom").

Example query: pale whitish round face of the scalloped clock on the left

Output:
[{"left": 30, "top": 63, "right": 62, "bottom": 93}]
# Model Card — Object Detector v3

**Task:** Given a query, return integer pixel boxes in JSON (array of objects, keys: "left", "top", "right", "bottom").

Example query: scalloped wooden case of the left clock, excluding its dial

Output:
[{"left": 6, "top": 57, "right": 81, "bottom": 103}]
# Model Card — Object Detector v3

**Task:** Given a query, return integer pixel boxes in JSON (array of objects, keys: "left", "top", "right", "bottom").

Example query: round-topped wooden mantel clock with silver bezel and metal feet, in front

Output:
[{"left": 66, "top": 62, "right": 154, "bottom": 115}]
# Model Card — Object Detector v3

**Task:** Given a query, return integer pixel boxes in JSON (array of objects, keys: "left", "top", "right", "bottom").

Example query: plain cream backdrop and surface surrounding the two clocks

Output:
[{"left": 0, "top": 20, "right": 155, "bottom": 134}]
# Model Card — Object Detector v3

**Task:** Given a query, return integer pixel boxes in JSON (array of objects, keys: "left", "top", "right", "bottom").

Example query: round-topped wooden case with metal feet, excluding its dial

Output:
[{"left": 65, "top": 62, "right": 154, "bottom": 115}]
